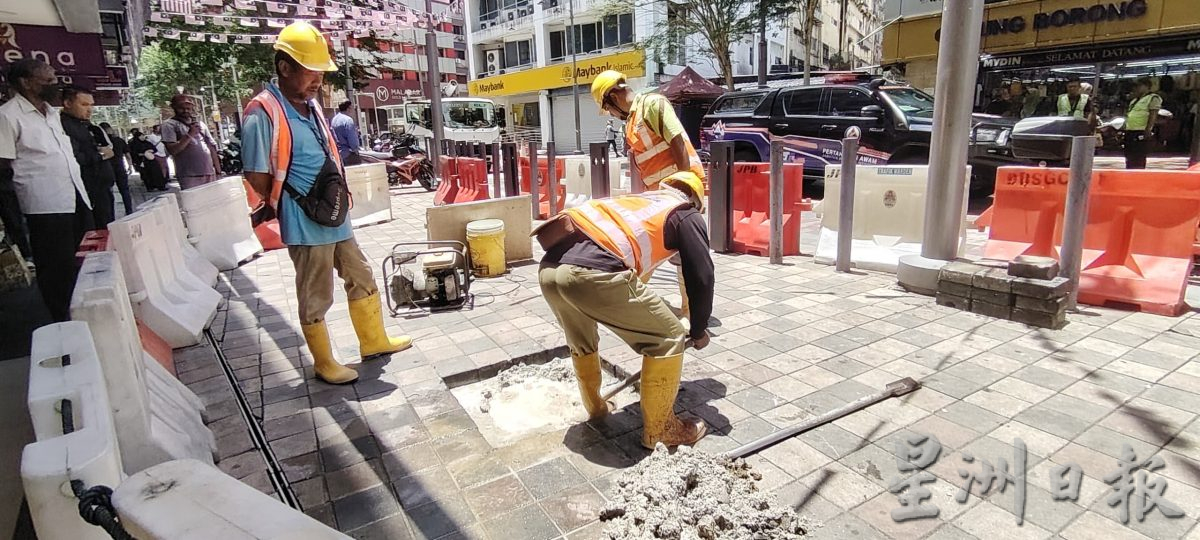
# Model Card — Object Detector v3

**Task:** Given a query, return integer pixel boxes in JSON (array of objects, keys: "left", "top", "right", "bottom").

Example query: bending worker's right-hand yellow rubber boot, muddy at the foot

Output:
[{"left": 642, "top": 354, "right": 708, "bottom": 450}]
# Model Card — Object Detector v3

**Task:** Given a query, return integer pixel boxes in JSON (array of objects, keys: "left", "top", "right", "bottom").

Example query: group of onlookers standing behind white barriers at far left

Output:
[{"left": 0, "top": 59, "right": 221, "bottom": 320}]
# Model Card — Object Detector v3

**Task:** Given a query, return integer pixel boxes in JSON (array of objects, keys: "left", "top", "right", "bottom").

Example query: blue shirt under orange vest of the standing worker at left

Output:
[{"left": 241, "top": 84, "right": 354, "bottom": 246}]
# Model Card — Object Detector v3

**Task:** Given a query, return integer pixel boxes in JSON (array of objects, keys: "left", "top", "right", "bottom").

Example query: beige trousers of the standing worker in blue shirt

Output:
[{"left": 288, "top": 236, "right": 379, "bottom": 324}]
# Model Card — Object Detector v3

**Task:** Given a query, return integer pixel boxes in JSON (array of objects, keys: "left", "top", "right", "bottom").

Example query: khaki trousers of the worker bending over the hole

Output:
[{"left": 538, "top": 264, "right": 686, "bottom": 356}]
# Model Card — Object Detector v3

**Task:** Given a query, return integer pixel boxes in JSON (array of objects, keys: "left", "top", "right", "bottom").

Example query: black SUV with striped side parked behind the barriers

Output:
[{"left": 701, "top": 77, "right": 1026, "bottom": 194}]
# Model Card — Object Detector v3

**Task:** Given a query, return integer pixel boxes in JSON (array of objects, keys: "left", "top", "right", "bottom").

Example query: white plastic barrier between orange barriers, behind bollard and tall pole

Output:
[{"left": 814, "top": 166, "right": 971, "bottom": 274}]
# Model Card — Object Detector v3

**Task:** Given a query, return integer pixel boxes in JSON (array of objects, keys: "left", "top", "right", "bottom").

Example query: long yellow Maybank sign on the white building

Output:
[{"left": 469, "top": 50, "right": 646, "bottom": 97}]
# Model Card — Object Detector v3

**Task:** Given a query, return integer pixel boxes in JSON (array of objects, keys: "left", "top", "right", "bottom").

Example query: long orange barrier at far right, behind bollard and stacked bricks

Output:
[{"left": 984, "top": 167, "right": 1200, "bottom": 316}]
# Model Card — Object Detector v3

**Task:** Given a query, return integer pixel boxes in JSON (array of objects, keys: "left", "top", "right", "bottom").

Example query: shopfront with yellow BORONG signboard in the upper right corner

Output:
[{"left": 883, "top": 0, "right": 1200, "bottom": 154}]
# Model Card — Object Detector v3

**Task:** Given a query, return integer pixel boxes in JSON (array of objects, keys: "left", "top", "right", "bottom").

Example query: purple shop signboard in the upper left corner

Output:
[{"left": 0, "top": 23, "right": 108, "bottom": 79}]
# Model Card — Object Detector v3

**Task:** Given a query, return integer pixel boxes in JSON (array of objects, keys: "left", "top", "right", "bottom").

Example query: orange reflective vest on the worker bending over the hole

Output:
[{"left": 563, "top": 190, "right": 691, "bottom": 277}]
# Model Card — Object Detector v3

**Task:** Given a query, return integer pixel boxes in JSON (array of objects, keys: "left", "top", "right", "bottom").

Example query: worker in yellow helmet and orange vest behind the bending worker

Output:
[{"left": 592, "top": 70, "right": 704, "bottom": 322}]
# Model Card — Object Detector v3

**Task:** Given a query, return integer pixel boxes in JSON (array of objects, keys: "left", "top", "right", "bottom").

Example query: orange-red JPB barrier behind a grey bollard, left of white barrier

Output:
[{"left": 731, "top": 162, "right": 804, "bottom": 257}]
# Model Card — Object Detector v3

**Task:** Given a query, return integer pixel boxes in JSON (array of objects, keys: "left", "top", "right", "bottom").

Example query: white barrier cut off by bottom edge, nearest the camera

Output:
[{"left": 113, "top": 460, "right": 349, "bottom": 540}]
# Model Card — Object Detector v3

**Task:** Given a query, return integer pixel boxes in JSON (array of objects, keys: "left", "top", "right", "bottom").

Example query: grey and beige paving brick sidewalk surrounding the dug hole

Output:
[{"left": 176, "top": 182, "right": 1200, "bottom": 540}]
